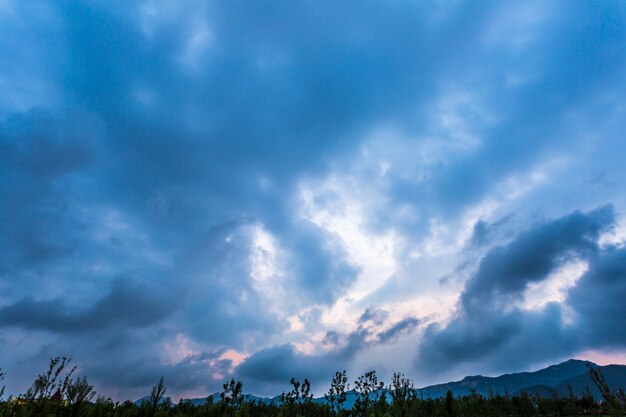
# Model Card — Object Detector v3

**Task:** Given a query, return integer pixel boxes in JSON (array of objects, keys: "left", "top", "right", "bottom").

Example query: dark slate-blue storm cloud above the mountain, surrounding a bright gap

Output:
[{"left": 416, "top": 206, "right": 624, "bottom": 371}]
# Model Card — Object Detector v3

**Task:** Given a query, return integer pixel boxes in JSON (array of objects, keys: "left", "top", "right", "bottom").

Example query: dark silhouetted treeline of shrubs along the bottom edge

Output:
[{"left": 0, "top": 358, "right": 626, "bottom": 417}]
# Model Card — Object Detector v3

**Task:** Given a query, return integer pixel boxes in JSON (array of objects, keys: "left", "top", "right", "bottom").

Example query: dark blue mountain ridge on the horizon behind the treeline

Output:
[{"left": 135, "top": 359, "right": 626, "bottom": 408}]
